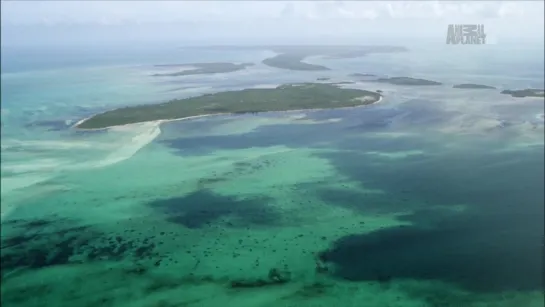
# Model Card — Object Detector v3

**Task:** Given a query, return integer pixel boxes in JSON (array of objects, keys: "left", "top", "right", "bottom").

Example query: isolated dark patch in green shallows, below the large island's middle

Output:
[{"left": 144, "top": 190, "right": 281, "bottom": 228}]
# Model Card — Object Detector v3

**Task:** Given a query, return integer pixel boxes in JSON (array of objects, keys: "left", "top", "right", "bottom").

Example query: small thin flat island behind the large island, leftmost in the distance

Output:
[{"left": 153, "top": 62, "right": 254, "bottom": 77}]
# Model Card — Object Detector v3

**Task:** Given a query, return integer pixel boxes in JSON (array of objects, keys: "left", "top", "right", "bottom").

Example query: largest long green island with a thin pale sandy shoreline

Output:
[{"left": 76, "top": 83, "right": 382, "bottom": 129}]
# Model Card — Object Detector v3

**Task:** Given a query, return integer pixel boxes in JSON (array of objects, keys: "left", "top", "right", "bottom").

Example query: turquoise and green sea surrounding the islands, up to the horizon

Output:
[{"left": 1, "top": 46, "right": 544, "bottom": 307}]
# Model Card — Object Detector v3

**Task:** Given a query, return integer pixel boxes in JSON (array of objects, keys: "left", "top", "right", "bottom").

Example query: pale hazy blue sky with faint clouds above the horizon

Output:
[{"left": 1, "top": 1, "right": 544, "bottom": 46}]
